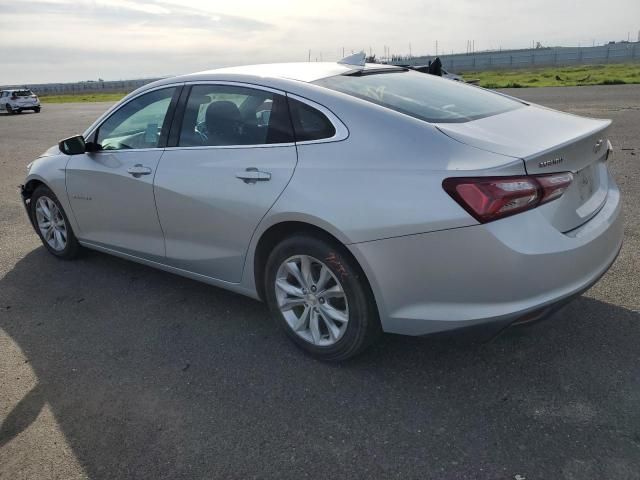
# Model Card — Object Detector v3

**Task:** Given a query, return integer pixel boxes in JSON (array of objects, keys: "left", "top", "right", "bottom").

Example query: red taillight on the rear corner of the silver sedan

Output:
[{"left": 442, "top": 172, "right": 573, "bottom": 223}]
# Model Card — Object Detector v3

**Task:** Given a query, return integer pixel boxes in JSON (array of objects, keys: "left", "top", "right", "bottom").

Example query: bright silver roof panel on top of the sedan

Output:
[{"left": 193, "top": 62, "right": 398, "bottom": 82}]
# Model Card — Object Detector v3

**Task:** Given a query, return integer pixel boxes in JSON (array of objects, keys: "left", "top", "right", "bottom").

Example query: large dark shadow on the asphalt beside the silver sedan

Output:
[{"left": 0, "top": 247, "right": 640, "bottom": 479}]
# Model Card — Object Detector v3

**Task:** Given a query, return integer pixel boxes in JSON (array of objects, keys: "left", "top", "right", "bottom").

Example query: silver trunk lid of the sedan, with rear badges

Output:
[{"left": 436, "top": 105, "right": 611, "bottom": 232}]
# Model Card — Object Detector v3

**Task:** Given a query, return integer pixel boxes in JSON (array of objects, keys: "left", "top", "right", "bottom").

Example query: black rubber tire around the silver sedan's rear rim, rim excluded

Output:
[{"left": 264, "top": 234, "right": 382, "bottom": 362}]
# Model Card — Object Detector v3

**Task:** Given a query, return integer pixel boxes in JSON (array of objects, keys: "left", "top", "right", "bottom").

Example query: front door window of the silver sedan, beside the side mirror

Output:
[{"left": 96, "top": 87, "right": 176, "bottom": 150}]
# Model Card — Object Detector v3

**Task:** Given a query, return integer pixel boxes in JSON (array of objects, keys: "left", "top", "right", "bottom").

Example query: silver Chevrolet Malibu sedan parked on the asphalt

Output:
[{"left": 21, "top": 58, "right": 622, "bottom": 361}]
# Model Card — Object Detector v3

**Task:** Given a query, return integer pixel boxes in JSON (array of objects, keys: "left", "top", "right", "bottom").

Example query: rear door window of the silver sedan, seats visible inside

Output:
[{"left": 178, "top": 85, "right": 293, "bottom": 147}]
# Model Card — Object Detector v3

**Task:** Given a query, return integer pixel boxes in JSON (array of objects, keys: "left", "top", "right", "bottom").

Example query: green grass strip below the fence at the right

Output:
[{"left": 462, "top": 63, "right": 640, "bottom": 88}]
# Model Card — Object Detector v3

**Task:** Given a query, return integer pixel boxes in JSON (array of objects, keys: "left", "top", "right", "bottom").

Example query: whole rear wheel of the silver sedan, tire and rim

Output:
[{"left": 265, "top": 235, "right": 381, "bottom": 361}]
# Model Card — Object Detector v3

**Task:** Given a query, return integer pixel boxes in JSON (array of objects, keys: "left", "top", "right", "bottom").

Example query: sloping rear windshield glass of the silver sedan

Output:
[{"left": 313, "top": 70, "right": 526, "bottom": 123}]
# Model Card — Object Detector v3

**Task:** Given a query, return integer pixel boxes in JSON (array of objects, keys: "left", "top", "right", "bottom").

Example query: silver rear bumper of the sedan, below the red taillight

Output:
[{"left": 349, "top": 174, "right": 623, "bottom": 335}]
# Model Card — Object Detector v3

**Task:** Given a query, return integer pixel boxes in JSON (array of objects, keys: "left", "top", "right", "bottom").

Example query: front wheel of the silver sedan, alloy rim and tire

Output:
[{"left": 29, "top": 185, "right": 80, "bottom": 260}]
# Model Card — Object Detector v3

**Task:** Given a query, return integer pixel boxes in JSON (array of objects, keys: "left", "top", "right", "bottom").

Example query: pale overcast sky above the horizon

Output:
[{"left": 0, "top": 0, "right": 640, "bottom": 85}]
